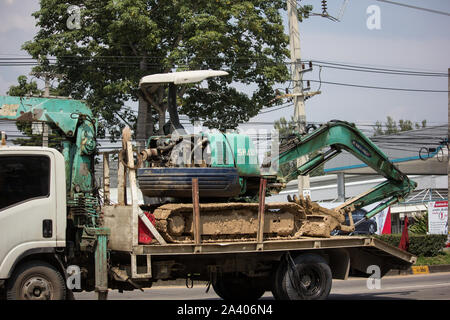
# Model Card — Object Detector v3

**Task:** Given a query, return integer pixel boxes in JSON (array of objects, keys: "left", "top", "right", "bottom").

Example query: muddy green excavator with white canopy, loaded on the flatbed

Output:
[{"left": 137, "top": 70, "right": 417, "bottom": 243}]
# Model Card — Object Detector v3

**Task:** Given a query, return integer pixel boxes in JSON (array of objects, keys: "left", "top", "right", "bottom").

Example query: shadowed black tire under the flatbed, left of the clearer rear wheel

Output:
[{"left": 212, "top": 275, "right": 266, "bottom": 301}]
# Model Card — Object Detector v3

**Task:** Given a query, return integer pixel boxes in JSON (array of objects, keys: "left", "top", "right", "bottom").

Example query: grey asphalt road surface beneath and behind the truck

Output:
[{"left": 75, "top": 273, "right": 450, "bottom": 300}]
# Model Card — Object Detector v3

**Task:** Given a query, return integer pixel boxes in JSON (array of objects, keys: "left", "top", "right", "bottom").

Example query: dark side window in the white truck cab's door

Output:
[{"left": 0, "top": 155, "right": 50, "bottom": 210}]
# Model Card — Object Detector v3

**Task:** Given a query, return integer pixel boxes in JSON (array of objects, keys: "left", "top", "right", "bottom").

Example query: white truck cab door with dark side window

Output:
[{"left": 0, "top": 149, "right": 57, "bottom": 279}]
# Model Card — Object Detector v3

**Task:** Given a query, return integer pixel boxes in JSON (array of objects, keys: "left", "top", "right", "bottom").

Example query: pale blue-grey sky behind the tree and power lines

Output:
[{"left": 0, "top": 0, "right": 450, "bottom": 135}]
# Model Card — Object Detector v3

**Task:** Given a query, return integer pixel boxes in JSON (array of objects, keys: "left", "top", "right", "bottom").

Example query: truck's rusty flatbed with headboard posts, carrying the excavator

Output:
[{"left": 98, "top": 145, "right": 416, "bottom": 299}]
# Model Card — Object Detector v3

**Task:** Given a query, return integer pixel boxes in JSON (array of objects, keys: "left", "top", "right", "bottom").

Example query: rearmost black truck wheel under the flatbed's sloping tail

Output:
[{"left": 279, "top": 254, "right": 332, "bottom": 300}]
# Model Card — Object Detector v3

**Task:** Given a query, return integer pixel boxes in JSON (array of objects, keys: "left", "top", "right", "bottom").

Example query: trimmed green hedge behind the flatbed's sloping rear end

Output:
[{"left": 376, "top": 234, "right": 447, "bottom": 257}]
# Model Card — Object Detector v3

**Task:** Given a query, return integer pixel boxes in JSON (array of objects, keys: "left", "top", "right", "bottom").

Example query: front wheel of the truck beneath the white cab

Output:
[{"left": 7, "top": 261, "right": 66, "bottom": 300}]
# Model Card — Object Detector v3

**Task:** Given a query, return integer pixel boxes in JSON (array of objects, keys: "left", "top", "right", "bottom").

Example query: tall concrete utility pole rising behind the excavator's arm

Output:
[{"left": 287, "top": 0, "right": 311, "bottom": 197}]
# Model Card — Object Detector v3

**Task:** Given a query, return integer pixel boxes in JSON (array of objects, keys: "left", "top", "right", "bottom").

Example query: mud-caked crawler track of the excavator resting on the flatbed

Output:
[{"left": 153, "top": 202, "right": 339, "bottom": 243}]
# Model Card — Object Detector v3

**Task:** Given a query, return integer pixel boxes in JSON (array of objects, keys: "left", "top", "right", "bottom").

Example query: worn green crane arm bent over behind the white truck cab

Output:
[{"left": 0, "top": 96, "right": 97, "bottom": 198}]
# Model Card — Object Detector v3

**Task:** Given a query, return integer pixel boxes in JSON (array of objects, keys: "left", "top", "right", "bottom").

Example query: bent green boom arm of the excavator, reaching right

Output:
[{"left": 266, "top": 121, "right": 417, "bottom": 218}]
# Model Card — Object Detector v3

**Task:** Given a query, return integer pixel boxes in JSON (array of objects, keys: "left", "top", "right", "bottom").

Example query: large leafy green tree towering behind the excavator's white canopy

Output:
[{"left": 23, "top": 0, "right": 312, "bottom": 138}]
